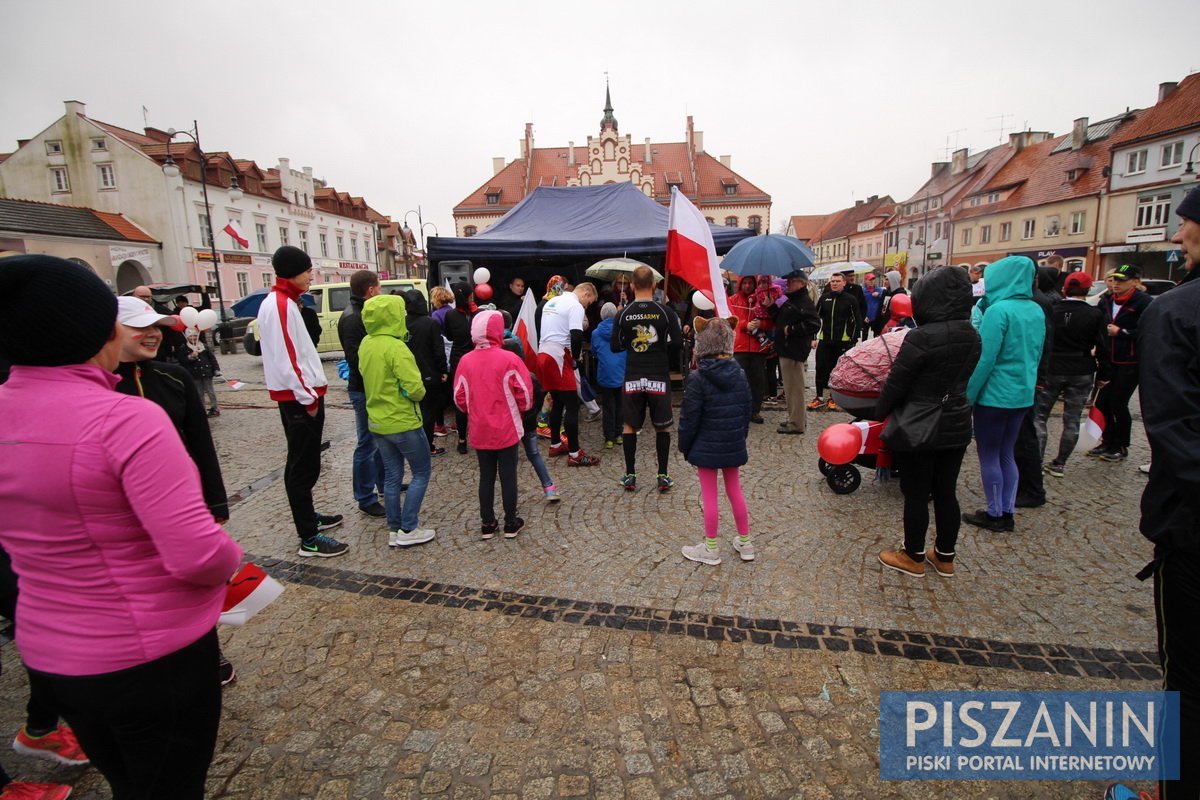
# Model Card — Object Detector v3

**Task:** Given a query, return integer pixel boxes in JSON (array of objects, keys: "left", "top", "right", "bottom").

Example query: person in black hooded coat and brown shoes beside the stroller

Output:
[{"left": 875, "top": 266, "right": 980, "bottom": 577}]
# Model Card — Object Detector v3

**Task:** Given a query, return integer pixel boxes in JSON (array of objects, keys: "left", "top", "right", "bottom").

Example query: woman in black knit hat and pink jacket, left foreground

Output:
[{"left": 0, "top": 255, "right": 241, "bottom": 800}]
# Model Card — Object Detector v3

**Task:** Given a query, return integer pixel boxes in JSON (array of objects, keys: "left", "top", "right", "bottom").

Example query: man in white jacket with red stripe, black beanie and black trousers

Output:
[{"left": 258, "top": 246, "right": 349, "bottom": 558}]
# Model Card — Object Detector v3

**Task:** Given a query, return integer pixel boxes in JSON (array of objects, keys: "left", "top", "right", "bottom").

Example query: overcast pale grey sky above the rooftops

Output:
[{"left": 0, "top": 0, "right": 1200, "bottom": 235}]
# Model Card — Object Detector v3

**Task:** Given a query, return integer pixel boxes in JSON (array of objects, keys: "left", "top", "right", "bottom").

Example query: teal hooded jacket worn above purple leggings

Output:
[{"left": 967, "top": 255, "right": 1046, "bottom": 408}]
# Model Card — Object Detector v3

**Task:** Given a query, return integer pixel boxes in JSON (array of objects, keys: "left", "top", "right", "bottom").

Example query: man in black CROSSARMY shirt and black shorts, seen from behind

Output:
[{"left": 611, "top": 266, "right": 683, "bottom": 492}]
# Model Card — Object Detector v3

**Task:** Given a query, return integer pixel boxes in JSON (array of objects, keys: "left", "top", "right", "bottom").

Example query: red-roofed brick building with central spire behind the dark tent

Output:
[{"left": 454, "top": 89, "right": 770, "bottom": 236}]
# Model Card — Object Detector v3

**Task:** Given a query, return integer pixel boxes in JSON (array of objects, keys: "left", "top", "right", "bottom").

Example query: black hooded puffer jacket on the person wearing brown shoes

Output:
[{"left": 875, "top": 266, "right": 980, "bottom": 450}]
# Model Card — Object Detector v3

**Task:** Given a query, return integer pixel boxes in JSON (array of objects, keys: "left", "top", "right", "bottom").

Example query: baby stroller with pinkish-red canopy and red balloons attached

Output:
[{"left": 817, "top": 329, "right": 908, "bottom": 494}]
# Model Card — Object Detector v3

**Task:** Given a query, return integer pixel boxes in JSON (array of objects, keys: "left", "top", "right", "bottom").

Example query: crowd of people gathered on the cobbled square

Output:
[{"left": 0, "top": 183, "right": 1200, "bottom": 799}]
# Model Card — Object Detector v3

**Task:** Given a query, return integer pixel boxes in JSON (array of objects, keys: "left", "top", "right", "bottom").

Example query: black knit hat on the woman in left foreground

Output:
[{"left": 0, "top": 255, "right": 116, "bottom": 367}]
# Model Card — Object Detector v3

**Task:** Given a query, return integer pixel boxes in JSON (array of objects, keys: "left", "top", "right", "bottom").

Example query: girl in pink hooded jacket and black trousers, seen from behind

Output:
[{"left": 454, "top": 311, "right": 533, "bottom": 539}]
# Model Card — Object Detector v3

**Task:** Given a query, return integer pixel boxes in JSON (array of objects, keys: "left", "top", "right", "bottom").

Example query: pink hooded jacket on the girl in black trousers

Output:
[{"left": 454, "top": 311, "right": 533, "bottom": 450}]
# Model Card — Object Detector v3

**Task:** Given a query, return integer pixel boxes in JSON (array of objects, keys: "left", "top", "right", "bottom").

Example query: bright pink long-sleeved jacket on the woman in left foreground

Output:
[{"left": 0, "top": 365, "right": 241, "bottom": 675}]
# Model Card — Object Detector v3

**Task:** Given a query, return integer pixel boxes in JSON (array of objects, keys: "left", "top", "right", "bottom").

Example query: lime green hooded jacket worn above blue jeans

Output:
[{"left": 359, "top": 295, "right": 425, "bottom": 434}]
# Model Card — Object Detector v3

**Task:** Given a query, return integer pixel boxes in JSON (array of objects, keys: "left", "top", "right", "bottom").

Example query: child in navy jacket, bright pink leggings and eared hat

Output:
[{"left": 679, "top": 317, "right": 755, "bottom": 566}]
